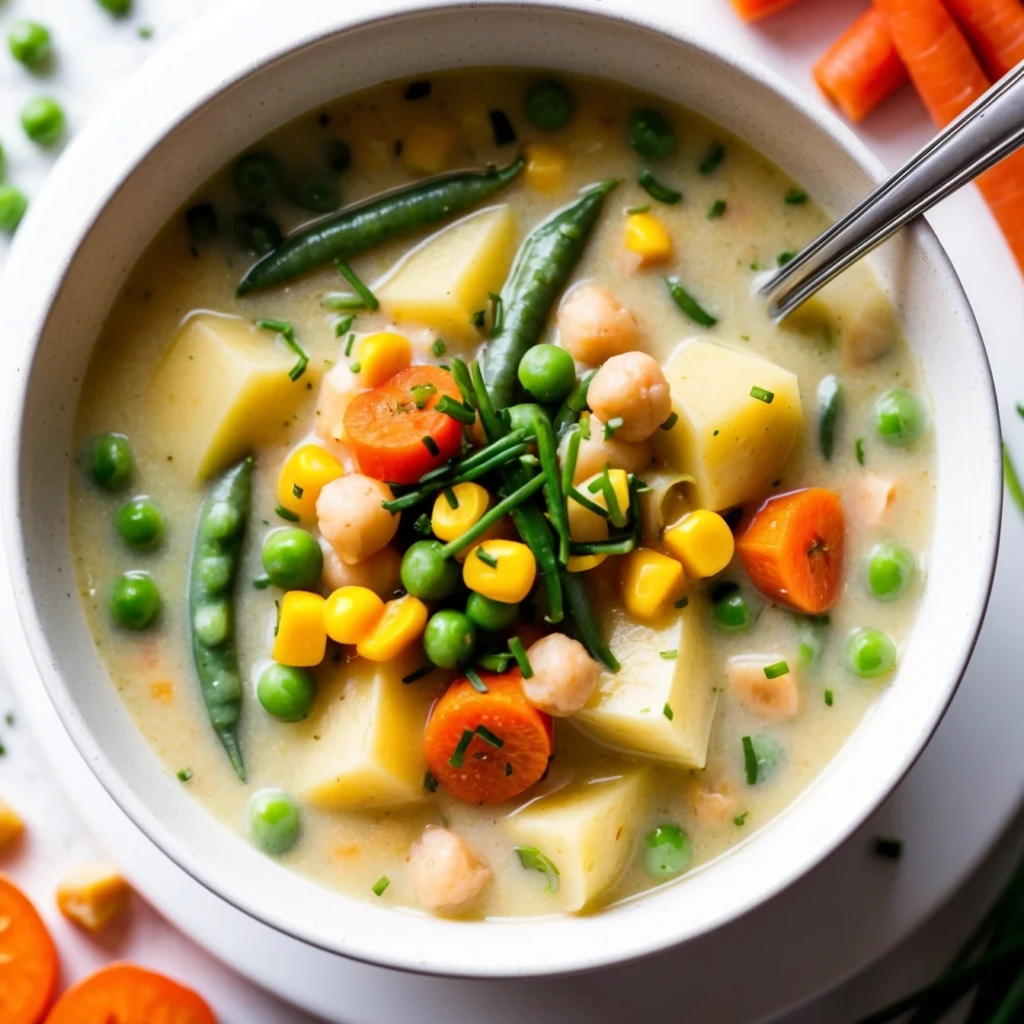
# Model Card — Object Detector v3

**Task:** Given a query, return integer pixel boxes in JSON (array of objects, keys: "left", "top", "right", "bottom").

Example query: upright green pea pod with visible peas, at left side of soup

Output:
[{"left": 188, "top": 458, "right": 254, "bottom": 782}]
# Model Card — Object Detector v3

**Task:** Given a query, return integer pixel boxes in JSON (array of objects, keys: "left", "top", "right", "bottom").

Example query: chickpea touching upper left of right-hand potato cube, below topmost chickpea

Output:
[{"left": 587, "top": 352, "right": 672, "bottom": 442}]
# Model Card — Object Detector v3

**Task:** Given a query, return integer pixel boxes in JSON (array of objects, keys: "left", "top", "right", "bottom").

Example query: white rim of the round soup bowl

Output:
[{"left": 0, "top": 0, "right": 1002, "bottom": 977}]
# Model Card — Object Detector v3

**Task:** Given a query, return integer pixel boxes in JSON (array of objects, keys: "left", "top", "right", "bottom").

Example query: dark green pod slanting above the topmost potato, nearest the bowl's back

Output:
[{"left": 238, "top": 157, "right": 525, "bottom": 295}]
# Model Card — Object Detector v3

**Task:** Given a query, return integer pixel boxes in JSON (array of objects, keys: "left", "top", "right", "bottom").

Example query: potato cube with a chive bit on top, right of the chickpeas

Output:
[{"left": 654, "top": 340, "right": 803, "bottom": 512}]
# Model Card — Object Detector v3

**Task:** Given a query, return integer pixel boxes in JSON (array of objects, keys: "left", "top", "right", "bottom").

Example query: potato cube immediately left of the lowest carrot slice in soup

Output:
[{"left": 298, "top": 653, "right": 434, "bottom": 810}]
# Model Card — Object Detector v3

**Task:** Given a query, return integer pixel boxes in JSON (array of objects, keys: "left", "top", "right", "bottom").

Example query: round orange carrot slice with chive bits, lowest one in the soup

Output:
[{"left": 424, "top": 669, "right": 553, "bottom": 804}]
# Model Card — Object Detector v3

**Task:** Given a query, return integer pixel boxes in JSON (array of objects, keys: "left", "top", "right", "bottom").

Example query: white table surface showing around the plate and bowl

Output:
[{"left": 0, "top": 0, "right": 1024, "bottom": 1024}]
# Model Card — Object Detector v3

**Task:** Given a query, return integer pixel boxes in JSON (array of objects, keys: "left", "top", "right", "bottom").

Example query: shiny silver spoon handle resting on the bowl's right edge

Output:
[{"left": 760, "top": 61, "right": 1024, "bottom": 324}]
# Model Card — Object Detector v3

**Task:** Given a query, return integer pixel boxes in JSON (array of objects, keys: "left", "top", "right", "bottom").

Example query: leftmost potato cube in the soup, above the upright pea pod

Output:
[{"left": 152, "top": 313, "right": 315, "bottom": 483}]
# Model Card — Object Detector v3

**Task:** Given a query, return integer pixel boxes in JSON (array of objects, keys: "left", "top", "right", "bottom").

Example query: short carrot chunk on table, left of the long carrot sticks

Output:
[{"left": 814, "top": 7, "right": 908, "bottom": 121}]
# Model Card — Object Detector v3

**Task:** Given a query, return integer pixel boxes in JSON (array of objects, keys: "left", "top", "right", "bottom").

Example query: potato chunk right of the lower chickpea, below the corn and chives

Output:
[{"left": 568, "top": 595, "right": 717, "bottom": 768}]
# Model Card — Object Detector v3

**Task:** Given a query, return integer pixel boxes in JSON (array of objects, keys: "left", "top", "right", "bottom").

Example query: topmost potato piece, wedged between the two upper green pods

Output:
[{"left": 374, "top": 206, "right": 515, "bottom": 343}]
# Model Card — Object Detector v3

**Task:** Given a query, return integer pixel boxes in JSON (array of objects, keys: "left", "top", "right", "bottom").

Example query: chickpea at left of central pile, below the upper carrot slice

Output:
[{"left": 316, "top": 473, "right": 399, "bottom": 565}]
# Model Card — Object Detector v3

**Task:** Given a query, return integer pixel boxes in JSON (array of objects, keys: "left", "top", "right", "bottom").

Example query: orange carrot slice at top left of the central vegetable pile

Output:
[{"left": 344, "top": 366, "right": 462, "bottom": 483}]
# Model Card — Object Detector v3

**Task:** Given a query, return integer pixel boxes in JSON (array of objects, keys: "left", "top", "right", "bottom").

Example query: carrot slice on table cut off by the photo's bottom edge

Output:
[{"left": 46, "top": 964, "right": 217, "bottom": 1024}]
